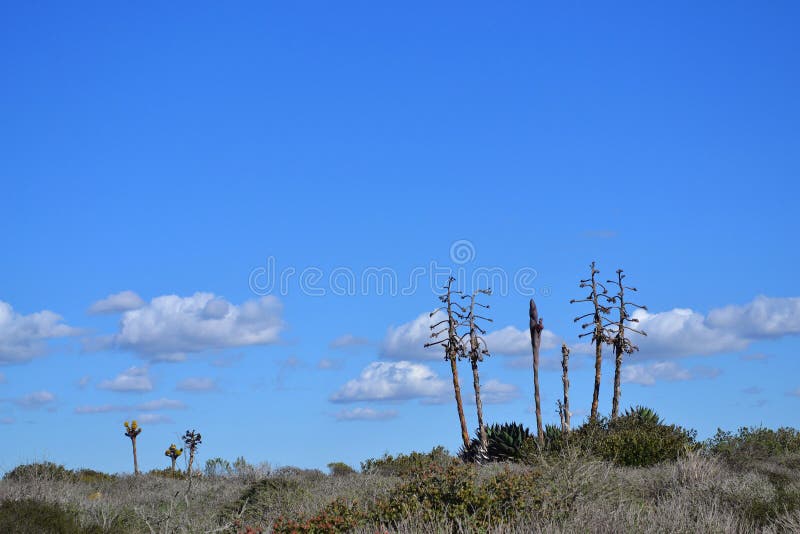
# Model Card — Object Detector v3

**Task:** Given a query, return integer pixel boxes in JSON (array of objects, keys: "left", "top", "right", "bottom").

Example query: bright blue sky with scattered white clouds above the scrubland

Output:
[{"left": 0, "top": 2, "right": 800, "bottom": 471}]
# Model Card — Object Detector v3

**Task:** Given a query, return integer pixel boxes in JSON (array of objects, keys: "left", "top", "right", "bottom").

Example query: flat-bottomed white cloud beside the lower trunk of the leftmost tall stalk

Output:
[{"left": 331, "top": 361, "right": 448, "bottom": 402}]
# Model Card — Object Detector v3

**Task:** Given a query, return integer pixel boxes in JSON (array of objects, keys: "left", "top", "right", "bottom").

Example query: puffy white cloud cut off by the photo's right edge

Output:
[{"left": 708, "top": 295, "right": 800, "bottom": 338}]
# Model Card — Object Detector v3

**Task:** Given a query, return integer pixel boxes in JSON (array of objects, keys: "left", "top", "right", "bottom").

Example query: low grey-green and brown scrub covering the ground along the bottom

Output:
[{"left": 0, "top": 420, "right": 800, "bottom": 534}]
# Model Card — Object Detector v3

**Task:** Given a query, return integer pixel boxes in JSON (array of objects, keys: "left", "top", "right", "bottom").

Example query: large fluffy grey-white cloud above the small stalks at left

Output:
[{"left": 95, "top": 293, "right": 284, "bottom": 360}]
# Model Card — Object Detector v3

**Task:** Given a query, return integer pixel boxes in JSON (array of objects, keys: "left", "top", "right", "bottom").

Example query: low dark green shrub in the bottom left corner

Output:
[{"left": 0, "top": 499, "right": 103, "bottom": 534}]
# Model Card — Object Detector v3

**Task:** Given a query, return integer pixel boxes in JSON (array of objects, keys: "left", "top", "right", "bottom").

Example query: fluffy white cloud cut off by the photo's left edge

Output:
[{"left": 0, "top": 301, "right": 79, "bottom": 363}]
